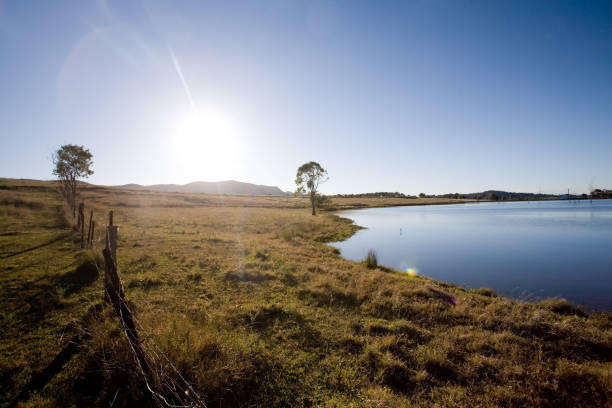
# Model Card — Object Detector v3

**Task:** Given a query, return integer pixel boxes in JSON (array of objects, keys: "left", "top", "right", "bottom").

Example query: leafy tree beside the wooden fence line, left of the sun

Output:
[{"left": 53, "top": 145, "right": 93, "bottom": 217}]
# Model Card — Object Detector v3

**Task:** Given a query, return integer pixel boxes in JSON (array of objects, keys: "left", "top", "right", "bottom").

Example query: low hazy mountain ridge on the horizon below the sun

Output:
[{"left": 117, "top": 180, "right": 288, "bottom": 196}]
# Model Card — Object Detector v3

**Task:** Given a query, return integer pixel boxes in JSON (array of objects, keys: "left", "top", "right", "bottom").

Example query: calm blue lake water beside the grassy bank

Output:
[{"left": 333, "top": 200, "right": 612, "bottom": 310}]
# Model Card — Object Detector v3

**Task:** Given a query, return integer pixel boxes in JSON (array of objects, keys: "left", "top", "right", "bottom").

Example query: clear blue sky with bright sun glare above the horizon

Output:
[{"left": 0, "top": 0, "right": 612, "bottom": 194}]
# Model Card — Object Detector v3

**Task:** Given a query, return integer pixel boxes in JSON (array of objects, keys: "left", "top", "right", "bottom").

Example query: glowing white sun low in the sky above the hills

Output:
[{"left": 172, "top": 109, "right": 243, "bottom": 181}]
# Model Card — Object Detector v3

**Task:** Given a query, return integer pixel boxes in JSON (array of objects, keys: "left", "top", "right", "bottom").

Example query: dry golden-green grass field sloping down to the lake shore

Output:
[{"left": 0, "top": 179, "right": 612, "bottom": 407}]
